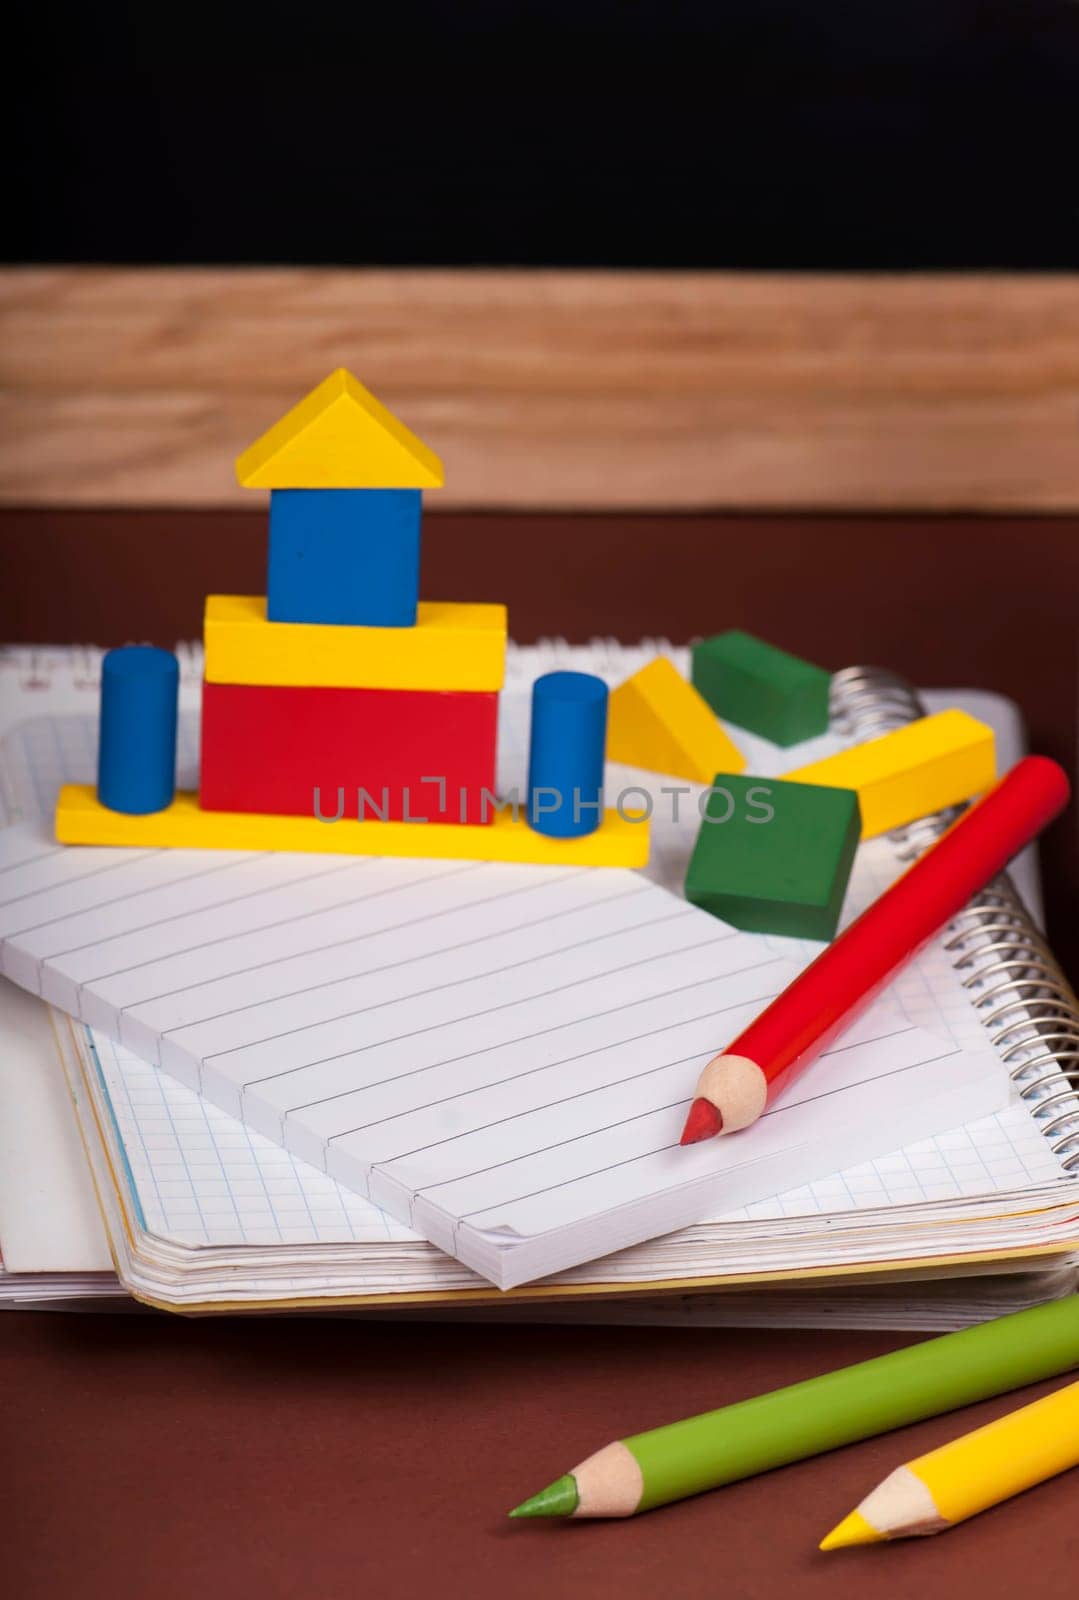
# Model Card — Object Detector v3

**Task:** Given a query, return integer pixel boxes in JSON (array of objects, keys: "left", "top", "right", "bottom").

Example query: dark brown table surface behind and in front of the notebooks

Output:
[{"left": 0, "top": 510, "right": 1079, "bottom": 1600}]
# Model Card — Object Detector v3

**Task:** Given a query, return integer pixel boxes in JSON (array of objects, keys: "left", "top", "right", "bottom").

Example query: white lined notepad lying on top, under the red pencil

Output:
[{"left": 0, "top": 827, "right": 1005, "bottom": 1286}]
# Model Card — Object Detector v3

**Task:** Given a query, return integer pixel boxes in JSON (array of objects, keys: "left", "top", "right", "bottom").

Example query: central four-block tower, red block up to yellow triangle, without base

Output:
[{"left": 200, "top": 370, "right": 506, "bottom": 824}]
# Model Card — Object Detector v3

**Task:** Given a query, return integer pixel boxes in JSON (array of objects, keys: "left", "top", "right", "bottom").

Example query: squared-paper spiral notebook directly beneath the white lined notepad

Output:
[{"left": 0, "top": 643, "right": 1074, "bottom": 1306}]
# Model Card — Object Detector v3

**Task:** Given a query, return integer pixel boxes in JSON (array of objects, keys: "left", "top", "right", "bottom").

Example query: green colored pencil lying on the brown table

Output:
[{"left": 509, "top": 1294, "right": 1079, "bottom": 1517}]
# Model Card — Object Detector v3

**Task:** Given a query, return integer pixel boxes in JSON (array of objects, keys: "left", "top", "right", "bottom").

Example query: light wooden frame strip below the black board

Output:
[{"left": 0, "top": 267, "right": 1079, "bottom": 510}]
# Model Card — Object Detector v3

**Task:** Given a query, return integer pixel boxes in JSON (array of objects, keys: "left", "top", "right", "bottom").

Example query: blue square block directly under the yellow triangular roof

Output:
[{"left": 266, "top": 490, "right": 419, "bottom": 627}]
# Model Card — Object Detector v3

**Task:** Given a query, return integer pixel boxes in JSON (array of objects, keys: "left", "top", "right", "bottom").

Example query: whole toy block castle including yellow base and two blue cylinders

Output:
[{"left": 56, "top": 370, "right": 648, "bottom": 867}]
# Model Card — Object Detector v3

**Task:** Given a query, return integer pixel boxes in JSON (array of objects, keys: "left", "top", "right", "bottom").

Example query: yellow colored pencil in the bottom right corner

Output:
[{"left": 821, "top": 1384, "right": 1079, "bottom": 1550}]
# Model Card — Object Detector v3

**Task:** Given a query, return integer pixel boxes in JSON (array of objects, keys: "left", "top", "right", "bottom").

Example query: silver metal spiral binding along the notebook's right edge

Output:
[{"left": 831, "top": 667, "right": 1079, "bottom": 1173}]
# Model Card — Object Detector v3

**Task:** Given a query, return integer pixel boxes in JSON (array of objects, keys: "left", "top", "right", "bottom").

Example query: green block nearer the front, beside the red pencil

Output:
[{"left": 685, "top": 773, "right": 861, "bottom": 939}]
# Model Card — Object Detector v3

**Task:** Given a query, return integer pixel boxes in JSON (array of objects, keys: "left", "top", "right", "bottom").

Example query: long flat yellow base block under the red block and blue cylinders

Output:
[{"left": 56, "top": 784, "right": 650, "bottom": 867}]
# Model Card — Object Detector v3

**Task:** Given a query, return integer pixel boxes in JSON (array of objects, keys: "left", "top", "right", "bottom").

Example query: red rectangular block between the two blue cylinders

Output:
[{"left": 199, "top": 683, "right": 498, "bottom": 822}]
